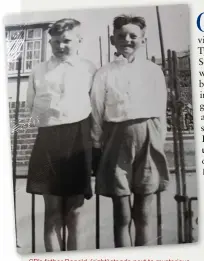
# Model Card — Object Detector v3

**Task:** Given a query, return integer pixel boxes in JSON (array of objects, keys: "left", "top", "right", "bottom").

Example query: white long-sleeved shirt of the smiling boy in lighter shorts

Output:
[{"left": 91, "top": 53, "right": 167, "bottom": 148}]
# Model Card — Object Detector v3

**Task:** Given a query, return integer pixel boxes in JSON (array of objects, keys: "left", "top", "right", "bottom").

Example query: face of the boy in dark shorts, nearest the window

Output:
[{"left": 50, "top": 28, "right": 81, "bottom": 58}]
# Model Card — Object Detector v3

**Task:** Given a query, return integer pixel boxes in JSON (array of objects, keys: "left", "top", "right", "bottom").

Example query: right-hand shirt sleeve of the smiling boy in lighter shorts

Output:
[{"left": 156, "top": 65, "right": 167, "bottom": 141}]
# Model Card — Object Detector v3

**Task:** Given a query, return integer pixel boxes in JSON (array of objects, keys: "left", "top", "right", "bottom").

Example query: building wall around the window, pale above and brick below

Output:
[{"left": 7, "top": 27, "right": 51, "bottom": 166}]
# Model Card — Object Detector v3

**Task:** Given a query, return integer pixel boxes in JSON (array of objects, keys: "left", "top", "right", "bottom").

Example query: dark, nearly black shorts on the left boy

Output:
[{"left": 26, "top": 117, "right": 92, "bottom": 198}]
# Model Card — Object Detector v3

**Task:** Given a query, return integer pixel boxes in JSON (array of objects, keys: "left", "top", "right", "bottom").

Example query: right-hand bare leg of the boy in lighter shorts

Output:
[{"left": 132, "top": 194, "right": 154, "bottom": 246}]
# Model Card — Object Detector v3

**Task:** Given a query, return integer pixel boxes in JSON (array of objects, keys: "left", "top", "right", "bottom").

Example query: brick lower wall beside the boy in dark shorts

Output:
[{"left": 9, "top": 102, "right": 37, "bottom": 166}]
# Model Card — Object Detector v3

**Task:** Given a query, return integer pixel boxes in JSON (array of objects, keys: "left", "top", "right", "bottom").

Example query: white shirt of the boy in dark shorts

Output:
[{"left": 27, "top": 56, "right": 95, "bottom": 127}]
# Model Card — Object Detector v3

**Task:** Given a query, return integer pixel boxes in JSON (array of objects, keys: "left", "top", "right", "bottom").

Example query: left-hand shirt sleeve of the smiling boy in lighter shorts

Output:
[{"left": 90, "top": 70, "right": 106, "bottom": 148}]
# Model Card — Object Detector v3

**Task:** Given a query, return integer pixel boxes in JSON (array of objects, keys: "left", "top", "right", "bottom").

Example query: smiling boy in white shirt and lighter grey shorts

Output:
[{"left": 91, "top": 16, "right": 169, "bottom": 247}]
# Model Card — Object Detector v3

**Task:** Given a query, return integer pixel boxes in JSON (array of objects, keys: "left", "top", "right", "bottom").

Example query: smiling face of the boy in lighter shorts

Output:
[{"left": 111, "top": 24, "right": 144, "bottom": 57}]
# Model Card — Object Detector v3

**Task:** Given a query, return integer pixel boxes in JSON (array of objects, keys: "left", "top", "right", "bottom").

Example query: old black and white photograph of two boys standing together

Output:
[{"left": 4, "top": 4, "right": 199, "bottom": 254}]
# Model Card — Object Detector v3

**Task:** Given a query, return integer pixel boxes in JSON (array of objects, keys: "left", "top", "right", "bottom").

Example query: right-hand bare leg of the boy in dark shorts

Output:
[{"left": 66, "top": 195, "right": 84, "bottom": 250}]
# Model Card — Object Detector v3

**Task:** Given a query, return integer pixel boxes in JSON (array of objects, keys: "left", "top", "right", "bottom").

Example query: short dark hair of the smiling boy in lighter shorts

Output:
[{"left": 113, "top": 15, "right": 146, "bottom": 34}]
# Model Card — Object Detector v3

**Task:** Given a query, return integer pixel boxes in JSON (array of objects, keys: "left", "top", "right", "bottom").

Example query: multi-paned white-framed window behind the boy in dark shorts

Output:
[{"left": 6, "top": 28, "right": 42, "bottom": 75}]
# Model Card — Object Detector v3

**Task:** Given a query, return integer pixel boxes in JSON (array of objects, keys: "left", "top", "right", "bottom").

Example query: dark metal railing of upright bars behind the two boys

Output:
[{"left": 13, "top": 35, "right": 197, "bottom": 253}]
